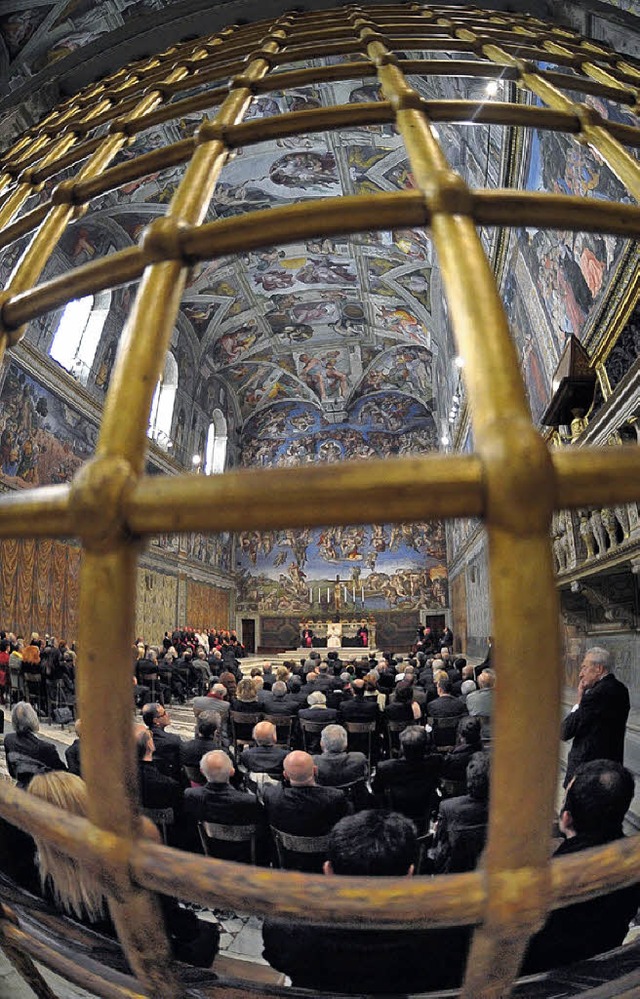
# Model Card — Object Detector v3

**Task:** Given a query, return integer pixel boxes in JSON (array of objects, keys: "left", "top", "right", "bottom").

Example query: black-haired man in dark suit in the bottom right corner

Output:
[{"left": 522, "top": 760, "right": 640, "bottom": 975}]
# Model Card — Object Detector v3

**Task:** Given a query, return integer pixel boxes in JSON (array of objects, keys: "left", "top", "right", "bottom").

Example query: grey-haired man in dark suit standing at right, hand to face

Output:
[{"left": 561, "top": 646, "right": 629, "bottom": 787}]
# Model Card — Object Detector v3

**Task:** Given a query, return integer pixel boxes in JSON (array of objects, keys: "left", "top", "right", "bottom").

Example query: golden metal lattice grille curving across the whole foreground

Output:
[{"left": 0, "top": 3, "right": 640, "bottom": 999}]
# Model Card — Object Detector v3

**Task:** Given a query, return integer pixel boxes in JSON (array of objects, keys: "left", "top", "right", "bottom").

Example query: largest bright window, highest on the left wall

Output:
[{"left": 49, "top": 290, "right": 111, "bottom": 385}]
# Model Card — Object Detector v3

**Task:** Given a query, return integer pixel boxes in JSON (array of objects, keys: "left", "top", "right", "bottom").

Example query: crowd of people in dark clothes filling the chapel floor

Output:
[{"left": 0, "top": 631, "right": 640, "bottom": 992}]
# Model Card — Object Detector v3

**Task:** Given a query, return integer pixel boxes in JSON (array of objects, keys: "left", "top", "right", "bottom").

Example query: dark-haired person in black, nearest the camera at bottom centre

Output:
[{"left": 262, "top": 811, "right": 470, "bottom": 995}]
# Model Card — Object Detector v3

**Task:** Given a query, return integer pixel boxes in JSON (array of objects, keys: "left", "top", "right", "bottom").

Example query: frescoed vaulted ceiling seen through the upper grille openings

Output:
[{"left": 38, "top": 63, "right": 508, "bottom": 454}]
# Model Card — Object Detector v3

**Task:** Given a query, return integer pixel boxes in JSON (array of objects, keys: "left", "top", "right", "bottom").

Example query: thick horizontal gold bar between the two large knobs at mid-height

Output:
[{"left": 124, "top": 454, "right": 483, "bottom": 534}]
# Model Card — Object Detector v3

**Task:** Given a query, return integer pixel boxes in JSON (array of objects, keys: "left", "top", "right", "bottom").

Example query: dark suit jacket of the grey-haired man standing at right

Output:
[{"left": 561, "top": 673, "right": 629, "bottom": 786}]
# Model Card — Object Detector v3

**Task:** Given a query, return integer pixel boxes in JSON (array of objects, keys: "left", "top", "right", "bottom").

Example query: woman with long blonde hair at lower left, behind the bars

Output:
[{"left": 28, "top": 773, "right": 220, "bottom": 968}]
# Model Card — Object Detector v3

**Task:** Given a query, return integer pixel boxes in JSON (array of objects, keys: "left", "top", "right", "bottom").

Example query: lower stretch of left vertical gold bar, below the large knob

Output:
[{"left": 73, "top": 544, "right": 180, "bottom": 999}]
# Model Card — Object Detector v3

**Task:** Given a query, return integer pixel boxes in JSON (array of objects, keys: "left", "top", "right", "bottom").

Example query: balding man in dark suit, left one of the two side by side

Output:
[{"left": 184, "top": 749, "right": 262, "bottom": 860}]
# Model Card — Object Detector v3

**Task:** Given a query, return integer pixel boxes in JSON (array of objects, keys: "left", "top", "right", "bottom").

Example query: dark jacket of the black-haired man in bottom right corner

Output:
[{"left": 521, "top": 831, "right": 640, "bottom": 975}]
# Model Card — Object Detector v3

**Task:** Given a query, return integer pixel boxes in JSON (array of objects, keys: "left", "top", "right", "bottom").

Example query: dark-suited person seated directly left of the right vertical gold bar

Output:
[{"left": 433, "top": 753, "right": 490, "bottom": 874}]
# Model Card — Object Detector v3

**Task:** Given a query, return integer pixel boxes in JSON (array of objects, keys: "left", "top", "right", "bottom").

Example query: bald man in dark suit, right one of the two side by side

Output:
[{"left": 264, "top": 750, "right": 351, "bottom": 870}]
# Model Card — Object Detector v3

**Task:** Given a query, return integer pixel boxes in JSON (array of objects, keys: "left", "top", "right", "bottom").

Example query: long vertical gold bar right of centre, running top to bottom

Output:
[{"left": 356, "top": 19, "right": 560, "bottom": 999}]
